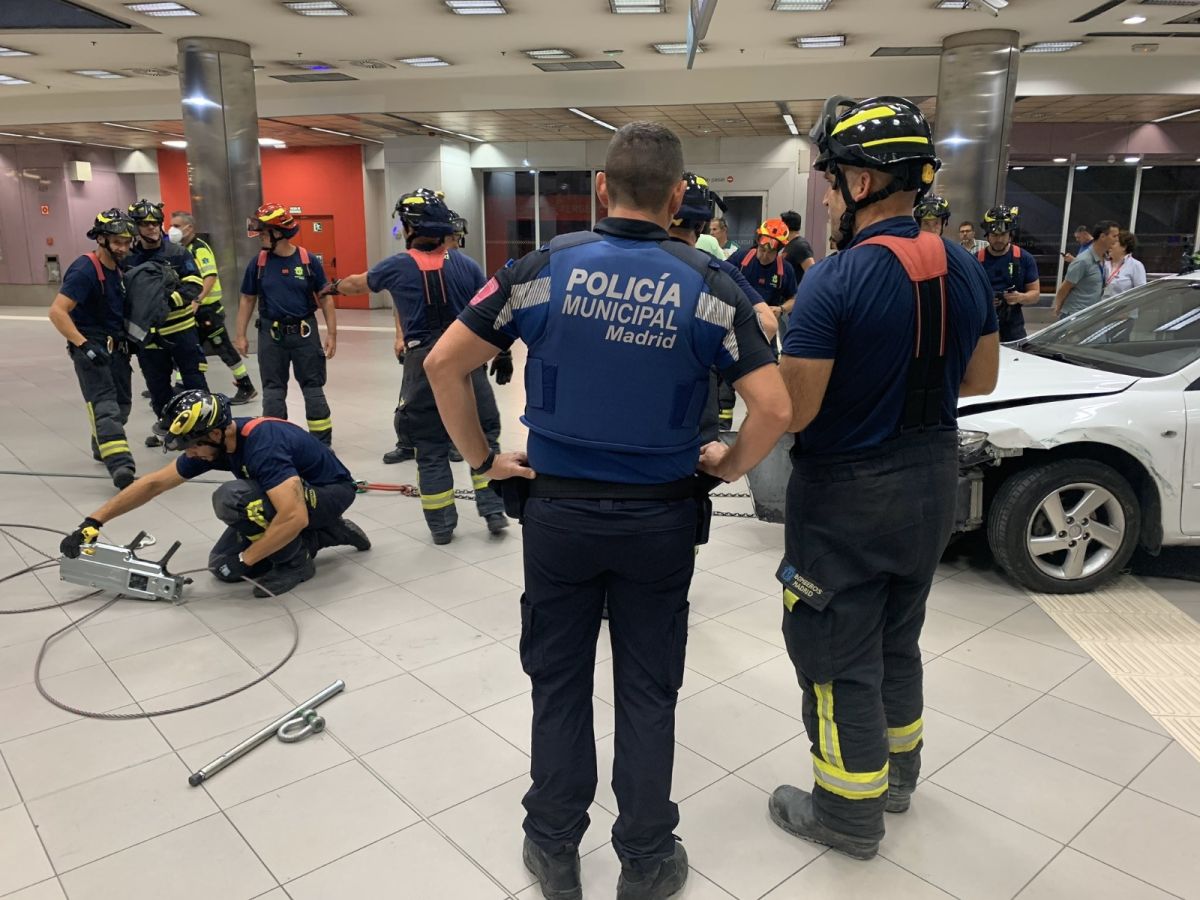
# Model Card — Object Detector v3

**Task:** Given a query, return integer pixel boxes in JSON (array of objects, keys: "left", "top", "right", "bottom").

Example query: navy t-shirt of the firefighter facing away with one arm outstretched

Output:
[{"left": 367, "top": 250, "right": 487, "bottom": 346}]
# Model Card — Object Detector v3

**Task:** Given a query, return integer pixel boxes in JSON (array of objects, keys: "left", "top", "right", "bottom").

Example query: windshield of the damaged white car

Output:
[{"left": 1020, "top": 278, "right": 1200, "bottom": 378}]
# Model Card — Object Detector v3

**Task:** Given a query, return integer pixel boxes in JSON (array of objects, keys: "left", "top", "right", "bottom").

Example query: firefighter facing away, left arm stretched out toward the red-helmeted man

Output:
[{"left": 334, "top": 188, "right": 512, "bottom": 544}]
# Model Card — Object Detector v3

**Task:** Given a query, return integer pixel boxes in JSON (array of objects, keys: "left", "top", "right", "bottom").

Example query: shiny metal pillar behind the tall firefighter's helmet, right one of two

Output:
[{"left": 936, "top": 29, "right": 1020, "bottom": 230}]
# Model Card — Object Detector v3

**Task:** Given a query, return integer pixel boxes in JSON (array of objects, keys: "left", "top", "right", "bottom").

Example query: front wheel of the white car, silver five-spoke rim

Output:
[{"left": 988, "top": 460, "right": 1141, "bottom": 594}]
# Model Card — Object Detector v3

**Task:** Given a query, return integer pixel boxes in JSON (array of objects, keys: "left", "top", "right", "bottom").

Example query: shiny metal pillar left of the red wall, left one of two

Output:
[{"left": 179, "top": 37, "right": 263, "bottom": 307}]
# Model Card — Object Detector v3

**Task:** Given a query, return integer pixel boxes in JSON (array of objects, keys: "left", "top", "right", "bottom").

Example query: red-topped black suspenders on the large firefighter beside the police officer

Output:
[{"left": 853, "top": 232, "right": 948, "bottom": 434}]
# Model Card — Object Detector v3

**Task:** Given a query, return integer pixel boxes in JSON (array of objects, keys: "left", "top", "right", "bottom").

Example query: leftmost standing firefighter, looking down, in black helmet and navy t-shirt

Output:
[{"left": 49, "top": 209, "right": 136, "bottom": 488}]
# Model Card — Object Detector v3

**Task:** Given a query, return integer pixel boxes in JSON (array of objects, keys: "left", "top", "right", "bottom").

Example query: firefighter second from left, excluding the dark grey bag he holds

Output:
[{"left": 125, "top": 200, "right": 209, "bottom": 446}]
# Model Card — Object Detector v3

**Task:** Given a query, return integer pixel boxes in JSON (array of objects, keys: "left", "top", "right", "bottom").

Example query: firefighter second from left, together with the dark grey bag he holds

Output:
[{"left": 126, "top": 200, "right": 209, "bottom": 446}]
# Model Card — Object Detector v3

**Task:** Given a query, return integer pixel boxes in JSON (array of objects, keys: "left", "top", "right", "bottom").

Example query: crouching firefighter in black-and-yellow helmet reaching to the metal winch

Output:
[{"left": 60, "top": 390, "right": 371, "bottom": 596}]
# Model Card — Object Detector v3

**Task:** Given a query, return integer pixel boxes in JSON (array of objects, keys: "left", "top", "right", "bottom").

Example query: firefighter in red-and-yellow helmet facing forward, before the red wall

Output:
[{"left": 233, "top": 203, "right": 337, "bottom": 446}]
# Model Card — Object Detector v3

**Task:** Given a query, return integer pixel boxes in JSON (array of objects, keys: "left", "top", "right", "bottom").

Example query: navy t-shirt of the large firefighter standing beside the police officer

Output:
[{"left": 784, "top": 216, "right": 996, "bottom": 456}]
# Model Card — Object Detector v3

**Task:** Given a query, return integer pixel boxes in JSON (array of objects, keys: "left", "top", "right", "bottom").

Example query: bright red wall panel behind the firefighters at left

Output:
[{"left": 158, "top": 145, "right": 367, "bottom": 310}]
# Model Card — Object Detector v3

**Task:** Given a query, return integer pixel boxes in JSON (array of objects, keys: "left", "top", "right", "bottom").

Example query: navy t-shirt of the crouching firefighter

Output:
[{"left": 175, "top": 419, "right": 354, "bottom": 491}]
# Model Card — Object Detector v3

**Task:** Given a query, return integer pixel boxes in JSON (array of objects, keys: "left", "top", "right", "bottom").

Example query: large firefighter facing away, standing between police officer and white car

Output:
[{"left": 768, "top": 97, "right": 1000, "bottom": 859}]
